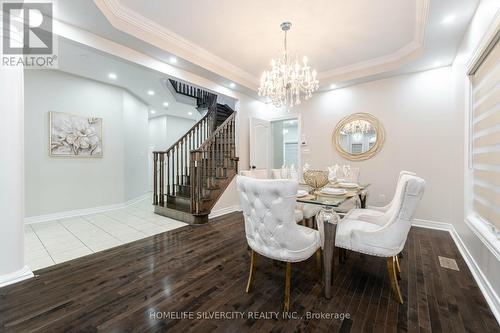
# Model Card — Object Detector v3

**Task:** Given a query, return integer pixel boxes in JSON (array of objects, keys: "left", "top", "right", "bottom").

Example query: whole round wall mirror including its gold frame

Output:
[{"left": 332, "top": 113, "right": 385, "bottom": 161}]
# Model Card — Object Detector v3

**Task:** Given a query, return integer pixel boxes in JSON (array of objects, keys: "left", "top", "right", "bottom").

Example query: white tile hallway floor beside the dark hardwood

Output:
[{"left": 24, "top": 200, "right": 186, "bottom": 270}]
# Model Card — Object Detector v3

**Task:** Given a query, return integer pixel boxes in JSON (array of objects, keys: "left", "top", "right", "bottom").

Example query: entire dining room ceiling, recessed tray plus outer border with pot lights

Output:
[{"left": 51, "top": 0, "right": 479, "bottom": 95}]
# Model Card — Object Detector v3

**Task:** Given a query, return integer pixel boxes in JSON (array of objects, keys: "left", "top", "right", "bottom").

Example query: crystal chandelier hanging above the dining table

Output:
[{"left": 259, "top": 22, "right": 319, "bottom": 108}]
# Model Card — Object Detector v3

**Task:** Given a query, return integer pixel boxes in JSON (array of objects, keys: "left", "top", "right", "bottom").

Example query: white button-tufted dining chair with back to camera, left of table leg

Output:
[{"left": 236, "top": 176, "right": 321, "bottom": 311}]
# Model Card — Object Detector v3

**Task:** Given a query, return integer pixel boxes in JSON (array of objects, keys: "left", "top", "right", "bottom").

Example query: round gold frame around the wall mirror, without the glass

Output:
[{"left": 332, "top": 113, "right": 385, "bottom": 161}]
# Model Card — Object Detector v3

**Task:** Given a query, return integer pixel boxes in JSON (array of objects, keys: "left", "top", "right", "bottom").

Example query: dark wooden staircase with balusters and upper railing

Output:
[{"left": 153, "top": 80, "right": 238, "bottom": 224}]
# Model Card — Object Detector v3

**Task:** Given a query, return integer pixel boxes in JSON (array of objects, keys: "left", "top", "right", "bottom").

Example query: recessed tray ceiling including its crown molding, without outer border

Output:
[{"left": 94, "top": 0, "right": 429, "bottom": 88}]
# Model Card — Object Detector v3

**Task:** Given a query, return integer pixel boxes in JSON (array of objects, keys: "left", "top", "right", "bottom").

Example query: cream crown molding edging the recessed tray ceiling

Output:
[{"left": 94, "top": 0, "right": 430, "bottom": 90}]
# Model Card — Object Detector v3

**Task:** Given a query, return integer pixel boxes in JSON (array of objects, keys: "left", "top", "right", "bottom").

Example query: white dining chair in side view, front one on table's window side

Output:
[{"left": 335, "top": 174, "right": 425, "bottom": 303}]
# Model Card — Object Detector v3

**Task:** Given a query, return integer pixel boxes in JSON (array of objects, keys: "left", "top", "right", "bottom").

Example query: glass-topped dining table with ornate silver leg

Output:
[{"left": 297, "top": 183, "right": 370, "bottom": 299}]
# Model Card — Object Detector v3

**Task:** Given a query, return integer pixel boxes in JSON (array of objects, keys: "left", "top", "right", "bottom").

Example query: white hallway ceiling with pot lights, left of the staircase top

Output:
[{"left": 58, "top": 39, "right": 201, "bottom": 120}]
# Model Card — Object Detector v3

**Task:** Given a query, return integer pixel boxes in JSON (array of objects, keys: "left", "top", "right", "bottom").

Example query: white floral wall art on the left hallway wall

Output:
[{"left": 49, "top": 112, "right": 102, "bottom": 157}]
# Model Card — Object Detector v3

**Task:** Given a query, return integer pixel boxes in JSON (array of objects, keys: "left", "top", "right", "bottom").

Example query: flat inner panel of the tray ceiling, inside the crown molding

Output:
[{"left": 118, "top": 0, "right": 418, "bottom": 74}]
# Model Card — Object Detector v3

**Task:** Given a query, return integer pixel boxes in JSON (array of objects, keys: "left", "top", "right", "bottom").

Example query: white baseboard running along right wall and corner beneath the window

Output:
[{"left": 412, "top": 219, "right": 500, "bottom": 324}]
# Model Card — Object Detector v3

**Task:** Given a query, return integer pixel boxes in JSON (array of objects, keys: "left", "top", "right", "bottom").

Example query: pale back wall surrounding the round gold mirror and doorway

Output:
[{"left": 216, "top": 67, "right": 462, "bottom": 223}]
